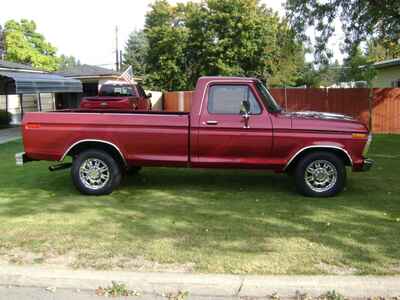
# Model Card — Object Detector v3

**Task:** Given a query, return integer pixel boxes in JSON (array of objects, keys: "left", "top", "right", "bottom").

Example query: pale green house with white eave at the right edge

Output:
[{"left": 372, "top": 58, "right": 400, "bottom": 88}]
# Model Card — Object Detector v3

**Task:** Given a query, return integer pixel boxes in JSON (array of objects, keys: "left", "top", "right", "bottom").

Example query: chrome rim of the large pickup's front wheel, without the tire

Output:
[{"left": 304, "top": 160, "right": 338, "bottom": 193}]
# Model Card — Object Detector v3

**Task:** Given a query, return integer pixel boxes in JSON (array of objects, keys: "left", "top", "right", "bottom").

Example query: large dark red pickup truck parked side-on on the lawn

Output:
[{"left": 16, "top": 77, "right": 373, "bottom": 197}]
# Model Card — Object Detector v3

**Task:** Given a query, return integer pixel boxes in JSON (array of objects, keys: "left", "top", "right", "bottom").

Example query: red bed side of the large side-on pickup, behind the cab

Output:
[{"left": 23, "top": 109, "right": 189, "bottom": 166}]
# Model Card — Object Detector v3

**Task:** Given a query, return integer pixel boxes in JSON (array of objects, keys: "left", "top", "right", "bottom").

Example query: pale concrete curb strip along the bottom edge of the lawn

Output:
[{"left": 0, "top": 266, "right": 400, "bottom": 298}]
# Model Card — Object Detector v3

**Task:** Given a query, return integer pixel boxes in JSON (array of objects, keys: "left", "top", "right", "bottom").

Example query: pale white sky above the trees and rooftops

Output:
[{"left": 0, "top": 0, "right": 342, "bottom": 68}]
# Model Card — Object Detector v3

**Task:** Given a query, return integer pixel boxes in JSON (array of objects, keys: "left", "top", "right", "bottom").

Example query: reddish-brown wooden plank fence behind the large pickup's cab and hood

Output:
[{"left": 164, "top": 88, "right": 400, "bottom": 133}]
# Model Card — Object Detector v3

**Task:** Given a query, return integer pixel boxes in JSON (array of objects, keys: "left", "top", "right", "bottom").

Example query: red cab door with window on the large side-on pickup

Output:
[{"left": 197, "top": 83, "right": 272, "bottom": 168}]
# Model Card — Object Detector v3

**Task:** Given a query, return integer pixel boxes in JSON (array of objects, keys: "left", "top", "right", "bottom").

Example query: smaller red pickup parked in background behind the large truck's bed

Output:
[{"left": 80, "top": 83, "right": 151, "bottom": 110}]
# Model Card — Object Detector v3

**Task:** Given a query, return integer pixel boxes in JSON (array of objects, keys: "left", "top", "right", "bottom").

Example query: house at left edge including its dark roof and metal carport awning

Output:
[{"left": 0, "top": 60, "right": 82, "bottom": 124}]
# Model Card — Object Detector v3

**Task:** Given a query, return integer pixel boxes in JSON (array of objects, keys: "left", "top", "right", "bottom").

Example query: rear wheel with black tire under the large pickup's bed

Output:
[{"left": 71, "top": 150, "right": 122, "bottom": 196}]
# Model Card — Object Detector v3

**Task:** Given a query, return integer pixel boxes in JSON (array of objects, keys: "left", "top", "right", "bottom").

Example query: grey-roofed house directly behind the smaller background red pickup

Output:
[{"left": 56, "top": 65, "right": 141, "bottom": 109}]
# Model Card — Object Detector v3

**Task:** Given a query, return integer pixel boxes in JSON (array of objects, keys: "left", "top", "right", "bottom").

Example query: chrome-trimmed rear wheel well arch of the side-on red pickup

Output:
[{"left": 64, "top": 141, "right": 127, "bottom": 168}]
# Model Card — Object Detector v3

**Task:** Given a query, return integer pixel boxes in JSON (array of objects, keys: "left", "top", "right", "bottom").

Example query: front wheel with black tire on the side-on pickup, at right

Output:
[{"left": 295, "top": 152, "right": 346, "bottom": 197}]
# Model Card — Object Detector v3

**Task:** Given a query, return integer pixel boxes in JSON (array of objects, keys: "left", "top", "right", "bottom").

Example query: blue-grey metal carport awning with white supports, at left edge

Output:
[{"left": 0, "top": 70, "right": 82, "bottom": 122}]
